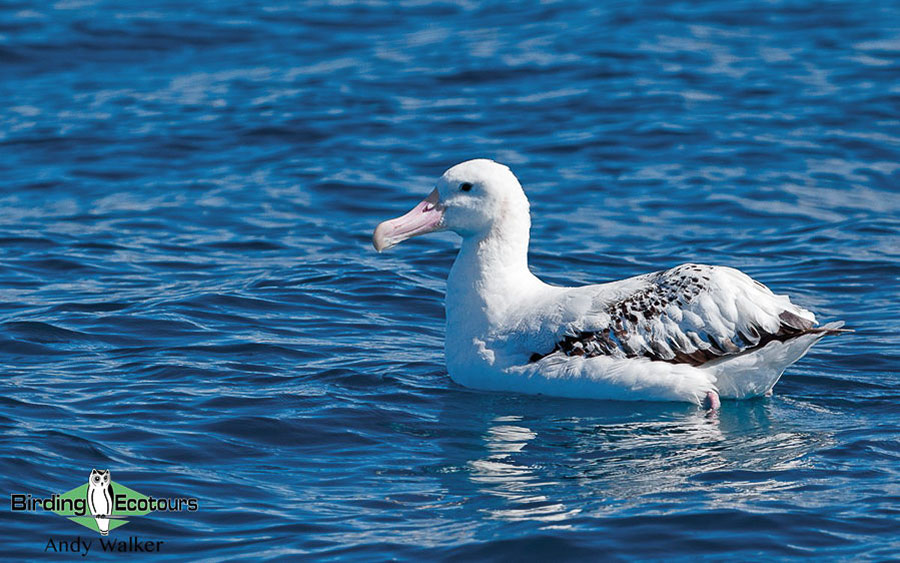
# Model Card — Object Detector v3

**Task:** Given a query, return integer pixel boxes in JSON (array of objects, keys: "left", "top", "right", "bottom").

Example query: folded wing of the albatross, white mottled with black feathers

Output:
[{"left": 530, "top": 264, "right": 840, "bottom": 366}]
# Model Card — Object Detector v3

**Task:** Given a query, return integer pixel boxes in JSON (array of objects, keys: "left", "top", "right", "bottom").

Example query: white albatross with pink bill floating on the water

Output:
[{"left": 373, "top": 159, "right": 843, "bottom": 408}]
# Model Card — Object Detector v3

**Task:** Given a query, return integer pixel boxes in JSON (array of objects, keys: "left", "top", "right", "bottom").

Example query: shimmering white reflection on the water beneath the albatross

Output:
[{"left": 441, "top": 398, "right": 830, "bottom": 527}]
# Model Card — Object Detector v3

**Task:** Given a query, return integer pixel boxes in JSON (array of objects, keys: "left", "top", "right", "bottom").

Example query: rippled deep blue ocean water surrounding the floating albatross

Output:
[{"left": 0, "top": 0, "right": 900, "bottom": 561}]
